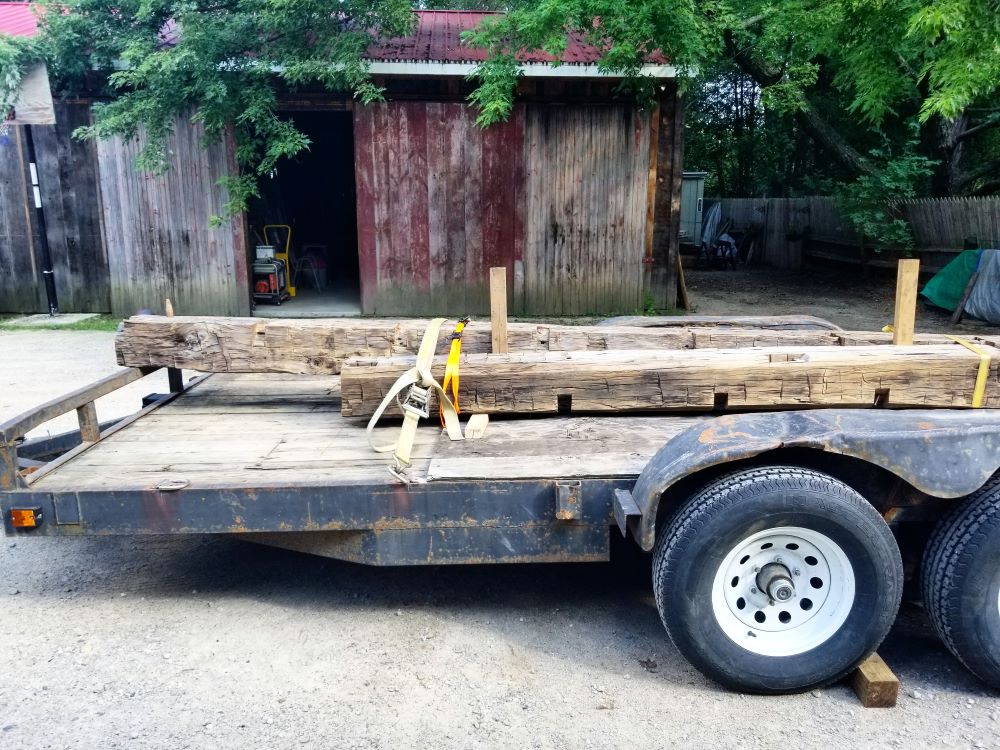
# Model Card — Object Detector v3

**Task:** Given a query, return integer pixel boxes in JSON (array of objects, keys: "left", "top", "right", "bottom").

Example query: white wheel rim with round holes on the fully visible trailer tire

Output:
[{"left": 712, "top": 526, "right": 860, "bottom": 656}]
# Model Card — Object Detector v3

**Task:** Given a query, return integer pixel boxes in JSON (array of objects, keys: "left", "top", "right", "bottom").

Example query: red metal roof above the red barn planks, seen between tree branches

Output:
[{"left": 365, "top": 10, "right": 620, "bottom": 65}]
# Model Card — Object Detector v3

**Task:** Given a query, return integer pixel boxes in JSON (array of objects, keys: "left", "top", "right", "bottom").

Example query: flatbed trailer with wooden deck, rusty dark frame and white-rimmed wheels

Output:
[{"left": 0, "top": 368, "right": 1000, "bottom": 693}]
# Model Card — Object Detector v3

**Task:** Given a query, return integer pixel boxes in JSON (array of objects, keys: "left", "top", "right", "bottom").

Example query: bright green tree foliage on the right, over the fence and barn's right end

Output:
[{"left": 470, "top": 0, "right": 1000, "bottom": 247}]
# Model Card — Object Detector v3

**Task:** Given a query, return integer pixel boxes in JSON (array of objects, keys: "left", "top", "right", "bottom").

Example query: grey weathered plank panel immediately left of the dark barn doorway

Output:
[{"left": 98, "top": 119, "right": 250, "bottom": 315}]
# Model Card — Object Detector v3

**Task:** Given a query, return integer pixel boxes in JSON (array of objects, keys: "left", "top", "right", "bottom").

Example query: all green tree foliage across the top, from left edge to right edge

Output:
[{"left": 0, "top": 0, "right": 1000, "bottom": 236}]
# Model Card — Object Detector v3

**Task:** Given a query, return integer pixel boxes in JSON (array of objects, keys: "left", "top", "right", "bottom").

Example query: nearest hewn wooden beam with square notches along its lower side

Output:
[{"left": 341, "top": 345, "right": 1000, "bottom": 417}]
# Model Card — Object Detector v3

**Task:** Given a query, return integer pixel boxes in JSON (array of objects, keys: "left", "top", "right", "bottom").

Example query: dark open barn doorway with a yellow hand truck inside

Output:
[{"left": 248, "top": 111, "right": 361, "bottom": 318}]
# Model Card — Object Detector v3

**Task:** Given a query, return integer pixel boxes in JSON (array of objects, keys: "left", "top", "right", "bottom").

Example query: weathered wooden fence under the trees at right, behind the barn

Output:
[{"left": 706, "top": 196, "right": 1000, "bottom": 271}]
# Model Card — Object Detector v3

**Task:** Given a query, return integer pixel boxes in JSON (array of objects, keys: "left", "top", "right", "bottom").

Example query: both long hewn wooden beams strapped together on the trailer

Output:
[{"left": 117, "top": 316, "right": 1000, "bottom": 417}]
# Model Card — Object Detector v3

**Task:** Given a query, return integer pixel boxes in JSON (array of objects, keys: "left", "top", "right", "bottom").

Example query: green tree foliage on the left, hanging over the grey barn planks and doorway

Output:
[{"left": 0, "top": 0, "right": 414, "bottom": 213}]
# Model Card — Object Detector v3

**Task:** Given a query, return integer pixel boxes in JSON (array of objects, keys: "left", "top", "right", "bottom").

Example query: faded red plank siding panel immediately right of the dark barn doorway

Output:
[{"left": 354, "top": 101, "right": 524, "bottom": 315}]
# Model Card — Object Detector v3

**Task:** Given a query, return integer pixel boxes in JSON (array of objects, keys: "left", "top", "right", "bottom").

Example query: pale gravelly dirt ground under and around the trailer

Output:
[{"left": 0, "top": 280, "right": 1000, "bottom": 750}]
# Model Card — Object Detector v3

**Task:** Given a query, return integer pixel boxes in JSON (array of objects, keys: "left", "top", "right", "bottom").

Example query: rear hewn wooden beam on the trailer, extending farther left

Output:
[{"left": 115, "top": 315, "right": 860, "bottom": 375}]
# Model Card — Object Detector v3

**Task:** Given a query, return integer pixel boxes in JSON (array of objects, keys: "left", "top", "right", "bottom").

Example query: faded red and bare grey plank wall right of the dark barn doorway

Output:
[{"left": 354, "top": 101, "right": 650, "bottom": 315}]
